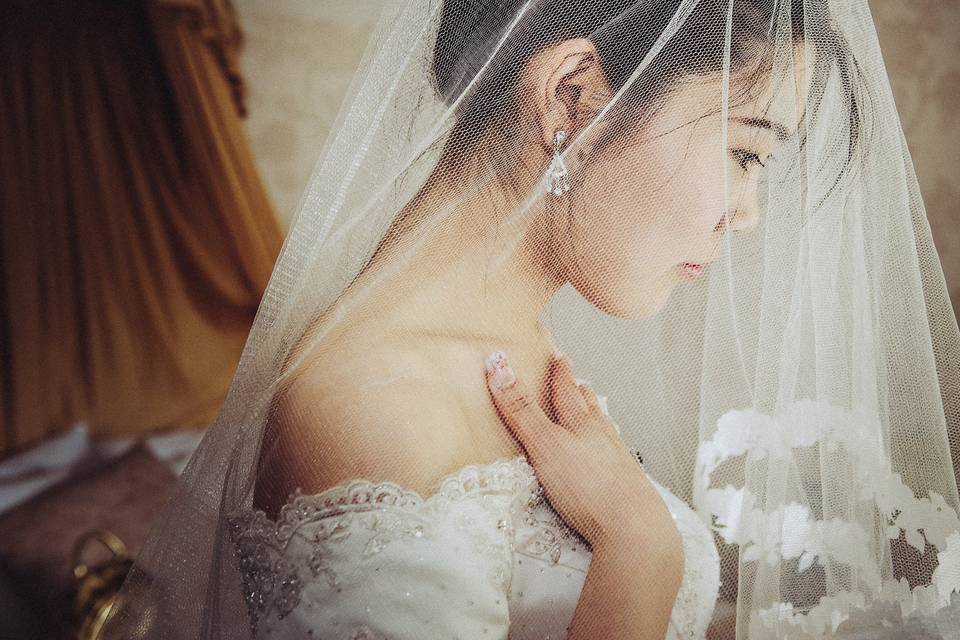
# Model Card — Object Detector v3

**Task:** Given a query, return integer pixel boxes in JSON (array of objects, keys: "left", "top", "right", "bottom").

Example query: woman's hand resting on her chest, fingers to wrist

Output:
[{"left": 486, "top": 351, "right": 683, "bottom": 559}]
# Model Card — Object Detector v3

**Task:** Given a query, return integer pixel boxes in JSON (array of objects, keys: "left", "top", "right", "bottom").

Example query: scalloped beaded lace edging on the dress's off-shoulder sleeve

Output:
[{"left": 227, "top": 456, "right": 538, "bottom": 632}]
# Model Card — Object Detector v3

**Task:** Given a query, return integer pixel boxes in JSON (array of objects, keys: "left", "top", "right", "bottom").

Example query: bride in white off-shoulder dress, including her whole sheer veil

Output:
[{"left": 103, "top": 0, "right": 960, "bottom": 640}]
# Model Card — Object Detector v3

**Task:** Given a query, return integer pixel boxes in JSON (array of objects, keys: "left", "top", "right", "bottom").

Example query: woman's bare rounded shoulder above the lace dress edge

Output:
[{"left": 254, "top": 344, "right": 470, "bottom": 514}]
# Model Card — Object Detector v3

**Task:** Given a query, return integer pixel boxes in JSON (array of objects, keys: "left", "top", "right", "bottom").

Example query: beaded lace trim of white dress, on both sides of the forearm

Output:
[{"left": 228, "top": 456, "right": 718, "bottom": 639}]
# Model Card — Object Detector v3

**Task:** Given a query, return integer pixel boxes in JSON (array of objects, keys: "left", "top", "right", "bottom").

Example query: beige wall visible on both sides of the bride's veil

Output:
[{"left": 234, "top": 0, "right": 960, "bottom": 310}]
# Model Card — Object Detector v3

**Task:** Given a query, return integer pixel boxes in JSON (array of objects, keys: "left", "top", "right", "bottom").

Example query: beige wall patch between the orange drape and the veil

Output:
[{"left": 234, "top": 0, "right": 383, "bottom": 226}]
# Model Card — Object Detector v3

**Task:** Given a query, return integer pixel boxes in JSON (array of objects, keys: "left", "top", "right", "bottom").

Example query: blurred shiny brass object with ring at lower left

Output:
[{"left": 71, "top": 529, "right": 133, "bottom": 640}]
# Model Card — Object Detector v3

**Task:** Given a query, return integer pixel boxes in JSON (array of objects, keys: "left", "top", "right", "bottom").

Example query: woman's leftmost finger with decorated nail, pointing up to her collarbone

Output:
[{"left": 485, "top": 351, "right": 556, "bottom": 455}]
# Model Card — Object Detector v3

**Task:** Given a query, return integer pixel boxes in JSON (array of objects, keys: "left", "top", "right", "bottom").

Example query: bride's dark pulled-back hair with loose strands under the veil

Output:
[{"left": 433, "top": 0, "right": 862, "bottom": 198}]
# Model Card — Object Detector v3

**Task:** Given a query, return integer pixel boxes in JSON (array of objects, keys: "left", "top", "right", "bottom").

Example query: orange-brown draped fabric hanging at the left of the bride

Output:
[{"left": 0, "top": 0, "right": 282, "bottom": 455}]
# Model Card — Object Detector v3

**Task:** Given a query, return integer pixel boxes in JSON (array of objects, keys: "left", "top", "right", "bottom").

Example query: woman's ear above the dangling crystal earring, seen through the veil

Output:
[{"left": 523, "top": 38, "right": 611, "bottom": 149}]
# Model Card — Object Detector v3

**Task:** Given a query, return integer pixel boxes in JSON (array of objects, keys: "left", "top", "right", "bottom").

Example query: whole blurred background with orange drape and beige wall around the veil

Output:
[{"left": 0, "top": 0, "right": 960, "bottom": 638}]
